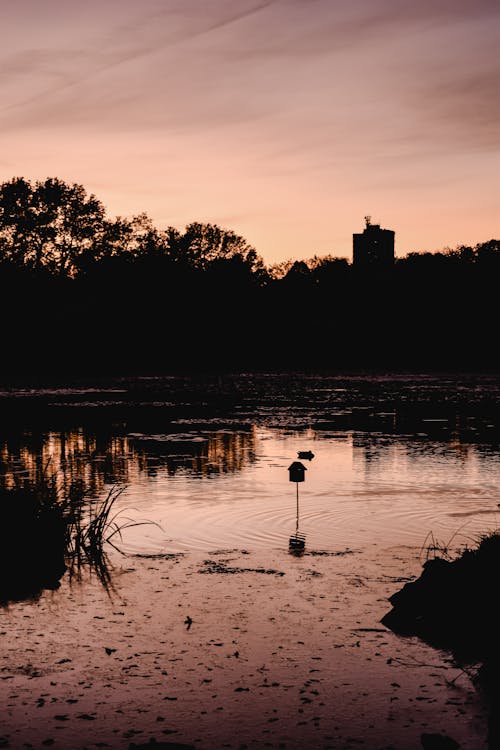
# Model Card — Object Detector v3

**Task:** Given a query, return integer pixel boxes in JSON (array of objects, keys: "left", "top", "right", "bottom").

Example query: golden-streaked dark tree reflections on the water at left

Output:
[{"left": 0, "top": 427, "right": 256, "bottom": 496}]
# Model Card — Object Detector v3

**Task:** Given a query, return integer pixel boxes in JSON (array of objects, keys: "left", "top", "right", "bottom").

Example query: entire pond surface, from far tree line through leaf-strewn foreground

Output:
[{"left": 0, "top": 375, "right": 500, "bottom": 750}]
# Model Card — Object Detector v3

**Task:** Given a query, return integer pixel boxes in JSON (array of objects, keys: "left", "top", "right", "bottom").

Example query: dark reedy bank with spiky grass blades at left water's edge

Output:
[{"left": 0, "top": 478, "right": 139, "bottom": 606}]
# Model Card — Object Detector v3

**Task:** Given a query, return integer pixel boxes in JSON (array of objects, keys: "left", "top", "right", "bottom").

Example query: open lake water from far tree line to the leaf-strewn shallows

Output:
[{"left": 1, "top": 376, "right": 500, "bottom": 552}]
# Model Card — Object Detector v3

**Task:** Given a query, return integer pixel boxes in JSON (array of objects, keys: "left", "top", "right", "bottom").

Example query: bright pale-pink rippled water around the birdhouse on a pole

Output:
[{"left": 121, "top": 428, "right": 500, "bottom": 551}]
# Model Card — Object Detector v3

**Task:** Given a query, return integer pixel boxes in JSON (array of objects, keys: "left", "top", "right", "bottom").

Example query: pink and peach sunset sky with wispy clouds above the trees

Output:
[{"left": 0, "top": 0, "right": 500, "bottom": 263}]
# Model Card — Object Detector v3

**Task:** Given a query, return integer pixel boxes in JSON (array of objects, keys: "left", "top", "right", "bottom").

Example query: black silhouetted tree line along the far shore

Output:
[{"left": 0, "top": 177, "right": 500, "bottom": 378}]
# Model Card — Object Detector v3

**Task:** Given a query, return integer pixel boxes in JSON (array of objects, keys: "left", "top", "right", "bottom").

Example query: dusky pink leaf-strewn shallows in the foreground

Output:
[{"left": 0, "top": 545, "right": 487, "bottom": 750}]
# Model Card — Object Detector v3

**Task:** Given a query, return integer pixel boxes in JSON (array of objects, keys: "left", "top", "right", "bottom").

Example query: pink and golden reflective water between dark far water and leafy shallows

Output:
[{"left": 0, "top": 427, "right": 500, "bottom": 552}]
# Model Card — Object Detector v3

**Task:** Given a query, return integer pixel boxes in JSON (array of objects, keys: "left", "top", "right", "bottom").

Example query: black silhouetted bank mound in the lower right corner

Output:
[{"left": 381, "top": 530, "right": 500, "bottom": 748}]
